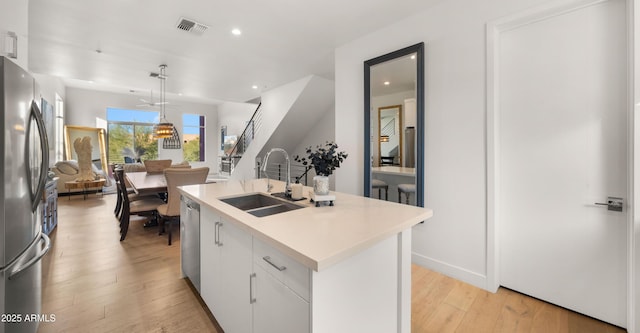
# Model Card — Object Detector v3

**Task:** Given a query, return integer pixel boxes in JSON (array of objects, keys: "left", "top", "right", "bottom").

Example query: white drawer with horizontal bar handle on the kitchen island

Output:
[{"left": 253, "top": 237, "right": 311, "bottom": 302}]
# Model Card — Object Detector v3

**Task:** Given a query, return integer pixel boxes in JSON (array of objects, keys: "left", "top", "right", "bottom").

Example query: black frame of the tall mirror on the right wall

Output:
[{"left": 364, "top": 42, "right": 425, "bottom": 207}]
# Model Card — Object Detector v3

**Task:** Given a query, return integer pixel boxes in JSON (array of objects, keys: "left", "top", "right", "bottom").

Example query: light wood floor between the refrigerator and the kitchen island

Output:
[{"left": 38, "top": 194, "right": 217, "bottom": 333}]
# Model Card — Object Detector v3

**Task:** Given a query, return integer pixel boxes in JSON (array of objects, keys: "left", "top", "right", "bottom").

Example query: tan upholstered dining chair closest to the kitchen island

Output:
[{"left": 157, "top": 167, "right": 209, "bottom": 245}]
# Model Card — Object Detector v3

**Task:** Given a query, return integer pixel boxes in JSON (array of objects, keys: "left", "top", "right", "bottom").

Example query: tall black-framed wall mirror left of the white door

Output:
[{"left": 364, "top": 43, "right": 424, "bottom": 207}]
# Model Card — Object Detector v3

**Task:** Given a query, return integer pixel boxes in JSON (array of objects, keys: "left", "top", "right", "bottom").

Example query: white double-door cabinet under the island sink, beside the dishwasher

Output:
[{"left": 200, "top": 209, "right": 252, "bottom": 333}]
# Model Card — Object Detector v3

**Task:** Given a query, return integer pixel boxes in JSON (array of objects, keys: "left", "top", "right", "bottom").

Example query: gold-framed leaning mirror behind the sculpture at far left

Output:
[{"left": 64, "top": 125, "right": 108, "bottom": 170}]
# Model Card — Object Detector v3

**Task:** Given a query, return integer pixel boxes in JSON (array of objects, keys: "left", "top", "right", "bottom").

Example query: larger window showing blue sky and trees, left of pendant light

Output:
[{"left": 107, "top": 108, "right": 159, "bottom": 164}]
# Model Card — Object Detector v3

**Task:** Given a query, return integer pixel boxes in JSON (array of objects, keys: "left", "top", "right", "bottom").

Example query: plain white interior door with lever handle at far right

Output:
[{"left": 496, "top": 0, "right": 629, "bottom": 327}]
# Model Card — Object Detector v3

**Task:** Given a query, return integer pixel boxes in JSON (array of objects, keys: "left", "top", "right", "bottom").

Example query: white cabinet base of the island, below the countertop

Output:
[{"left": 200, "top": 205, "right": 404, "bottom": 333}]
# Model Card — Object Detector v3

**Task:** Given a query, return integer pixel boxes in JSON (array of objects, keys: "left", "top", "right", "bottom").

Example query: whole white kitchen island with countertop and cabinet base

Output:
[{"left": 180, "top": 179, "right": 432, "bottom": 333}]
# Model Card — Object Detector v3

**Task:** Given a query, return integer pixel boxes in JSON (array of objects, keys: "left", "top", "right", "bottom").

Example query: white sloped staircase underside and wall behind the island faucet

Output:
[{"left": 221, "top": 76, "right": 335, "bottom": 179}]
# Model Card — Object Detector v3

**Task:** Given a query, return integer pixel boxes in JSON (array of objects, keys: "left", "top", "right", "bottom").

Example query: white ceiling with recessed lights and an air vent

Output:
[{"left": 29, "top": 0, "right": 444, "bottom": 103}]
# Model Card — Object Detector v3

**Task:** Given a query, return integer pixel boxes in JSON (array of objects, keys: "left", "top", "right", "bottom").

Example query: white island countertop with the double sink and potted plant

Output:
[{"left": 179, "top": 179, "right": 433, "bottom": 272}]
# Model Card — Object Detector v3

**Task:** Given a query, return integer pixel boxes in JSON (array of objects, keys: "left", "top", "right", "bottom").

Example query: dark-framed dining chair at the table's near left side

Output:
[{"left": 115, "top": 169, "right": 164, "bottom": 241}]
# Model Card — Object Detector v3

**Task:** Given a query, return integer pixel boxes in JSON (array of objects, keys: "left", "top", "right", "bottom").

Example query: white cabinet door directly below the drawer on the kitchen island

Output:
[{"left": 253, "top": 265, "right": 310, "bottom": 333}]
